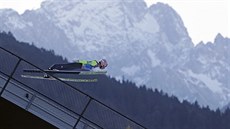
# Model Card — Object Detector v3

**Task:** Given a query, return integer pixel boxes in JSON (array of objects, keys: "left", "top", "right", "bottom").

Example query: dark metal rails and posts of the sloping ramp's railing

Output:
[{"left": 0, "top": 47, "right": 147, "bottom": 129}]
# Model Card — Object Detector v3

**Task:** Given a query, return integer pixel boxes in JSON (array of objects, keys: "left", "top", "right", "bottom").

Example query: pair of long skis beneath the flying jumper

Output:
[{"left": 21, "top": 69, "right": 106, "bottom": 82}]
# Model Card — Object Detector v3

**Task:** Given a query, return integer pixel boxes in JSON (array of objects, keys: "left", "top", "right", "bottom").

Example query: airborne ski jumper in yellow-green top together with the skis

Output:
[{"left": 21, "top": 59, "right": 108, "bottom": 82}]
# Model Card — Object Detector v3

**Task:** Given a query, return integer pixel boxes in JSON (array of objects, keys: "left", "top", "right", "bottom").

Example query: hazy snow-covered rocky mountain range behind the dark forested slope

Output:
[{"left": 0, "top": 0, "right": 230, "bottom": 108}]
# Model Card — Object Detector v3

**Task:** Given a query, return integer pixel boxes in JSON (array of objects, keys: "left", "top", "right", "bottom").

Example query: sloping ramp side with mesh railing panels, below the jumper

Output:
[{"left": 0, "top": 47, "right": 146, "bottom": 129}]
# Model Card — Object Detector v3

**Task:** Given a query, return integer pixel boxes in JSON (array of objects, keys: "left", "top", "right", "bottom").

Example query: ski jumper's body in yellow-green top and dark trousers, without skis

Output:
[{"left": 49, "top": 59, "right": 108, "bottom": 71}]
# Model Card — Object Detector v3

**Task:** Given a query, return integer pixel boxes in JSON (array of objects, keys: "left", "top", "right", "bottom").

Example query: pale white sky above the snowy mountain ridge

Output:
[{"left": 0, "top": 0, "right": 230, "bottom": 44}]
